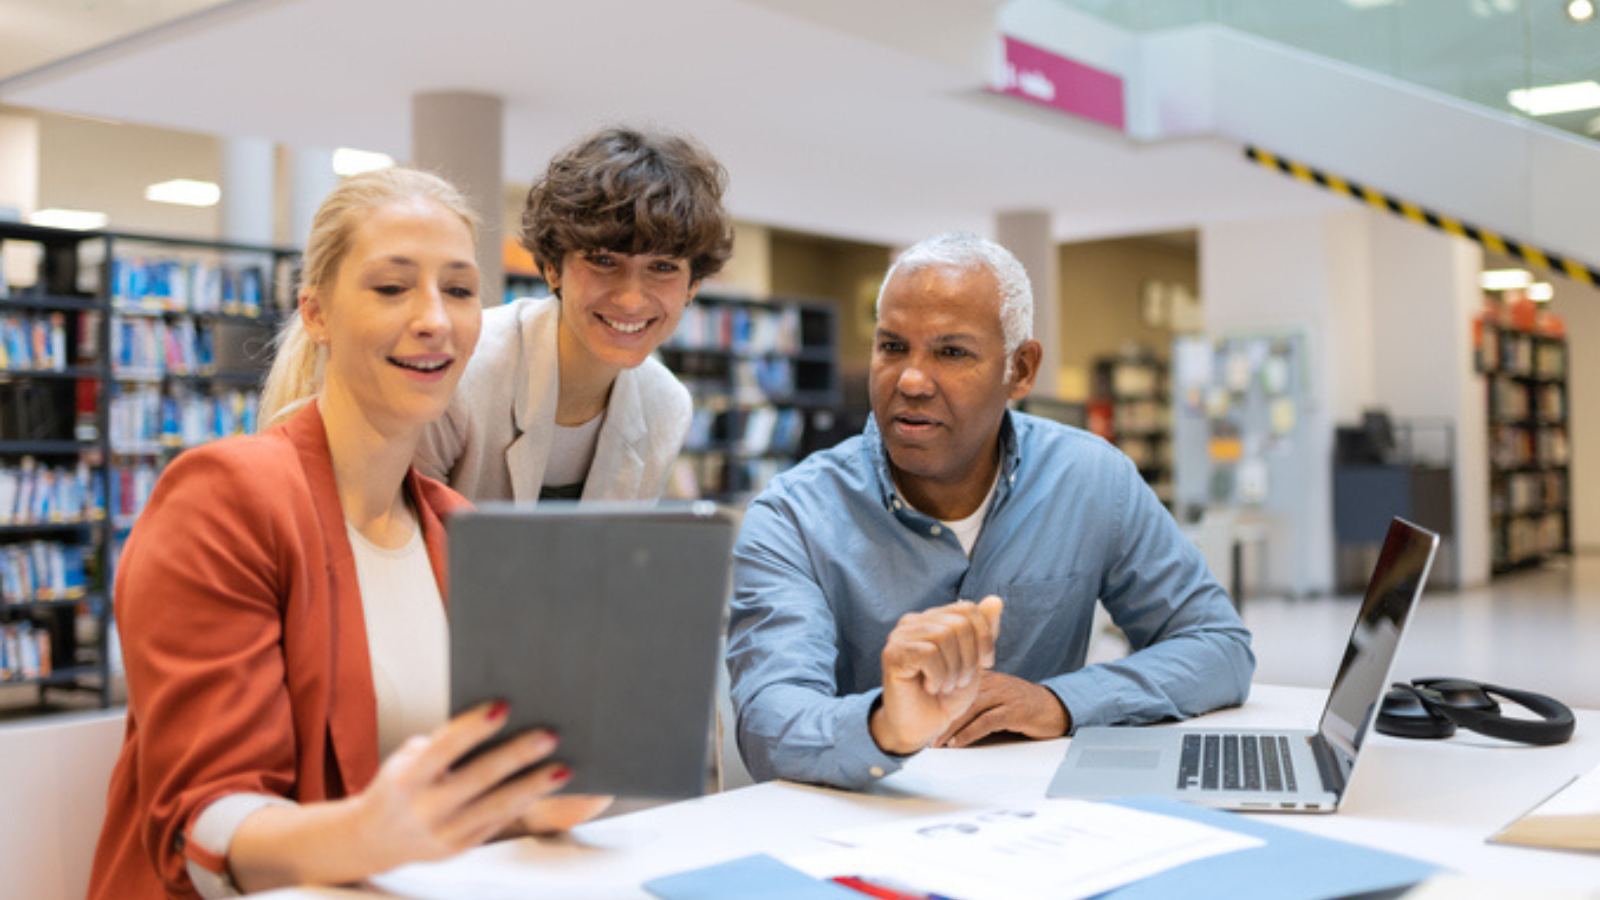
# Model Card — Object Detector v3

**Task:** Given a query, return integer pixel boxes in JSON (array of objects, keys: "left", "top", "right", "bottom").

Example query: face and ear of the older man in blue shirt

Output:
[{"left": 870, "top": 264, "right": 1037, "bottom": 500}]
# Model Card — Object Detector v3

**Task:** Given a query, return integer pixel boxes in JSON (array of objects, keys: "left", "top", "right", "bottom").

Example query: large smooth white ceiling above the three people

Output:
[{"left": 0, "top": 0, "right": 1344, "bottom": 243}]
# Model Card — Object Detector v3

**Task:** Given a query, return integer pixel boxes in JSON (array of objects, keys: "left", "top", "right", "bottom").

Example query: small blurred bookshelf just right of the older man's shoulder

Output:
[{"left": 1088, "top": 348, "right": 1173, "bottom": 506}]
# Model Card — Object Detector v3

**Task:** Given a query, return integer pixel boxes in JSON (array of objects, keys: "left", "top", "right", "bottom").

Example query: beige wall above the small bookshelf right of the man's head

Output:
[{"left": 1056, "top": 239, "right": 1200, "bottom": 400}]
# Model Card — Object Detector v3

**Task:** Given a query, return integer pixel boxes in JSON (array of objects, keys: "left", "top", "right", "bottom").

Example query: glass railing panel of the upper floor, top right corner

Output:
[{"left": 1059, "top": 0, "right": 1600, "bottom": 139}]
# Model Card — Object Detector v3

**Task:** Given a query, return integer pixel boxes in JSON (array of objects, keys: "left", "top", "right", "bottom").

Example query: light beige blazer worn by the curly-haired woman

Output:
[{"left": 416, "top": 298, "right": 693, "bottom": 501}]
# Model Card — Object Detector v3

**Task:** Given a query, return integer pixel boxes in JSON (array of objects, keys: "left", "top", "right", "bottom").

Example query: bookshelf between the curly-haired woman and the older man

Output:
[{"left": 661, "top": 293, "right": 842, "bottom": 503}]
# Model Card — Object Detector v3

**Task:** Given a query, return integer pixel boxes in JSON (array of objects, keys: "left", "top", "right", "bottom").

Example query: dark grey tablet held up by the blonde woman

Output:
[{"left": 448, "top": 503, "right": 734, "bottom": 799}]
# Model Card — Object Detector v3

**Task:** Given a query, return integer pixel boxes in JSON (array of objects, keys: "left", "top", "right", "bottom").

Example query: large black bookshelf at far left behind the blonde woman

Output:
[{"left": 0, "top": 223, "right": 298, "bottom": 706}]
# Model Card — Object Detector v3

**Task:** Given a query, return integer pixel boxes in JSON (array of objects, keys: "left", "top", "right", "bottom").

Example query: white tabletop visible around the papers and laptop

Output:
[{"left": 270, "top": 685, "right": 1600, "bottom": 900}]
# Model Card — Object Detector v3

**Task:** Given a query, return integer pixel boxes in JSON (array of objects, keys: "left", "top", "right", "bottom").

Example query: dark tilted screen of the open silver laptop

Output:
[{"left": 1317, "top": 519, "right": 1438, "bottom": 762}]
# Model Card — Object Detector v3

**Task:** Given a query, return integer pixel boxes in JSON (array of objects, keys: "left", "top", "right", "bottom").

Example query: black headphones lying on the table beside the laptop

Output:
[{"left": 1378, "top": 677, "right": 1576, "bottom": 746}]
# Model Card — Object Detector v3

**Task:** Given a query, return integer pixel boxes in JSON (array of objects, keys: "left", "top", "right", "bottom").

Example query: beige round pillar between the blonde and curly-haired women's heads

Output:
[{"left": 411, "top": 91, "right": 506, "bottom": 306}]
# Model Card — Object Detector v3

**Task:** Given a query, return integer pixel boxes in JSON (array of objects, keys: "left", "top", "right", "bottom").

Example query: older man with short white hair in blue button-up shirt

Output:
[{"left": 728, "top": 234, "right": 1254, "bottom": 788}]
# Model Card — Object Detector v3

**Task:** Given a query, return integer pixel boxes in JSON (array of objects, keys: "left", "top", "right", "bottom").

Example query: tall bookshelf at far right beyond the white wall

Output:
[{"left": 1475, "top": 299, "right": 1571, "bottom": 572}]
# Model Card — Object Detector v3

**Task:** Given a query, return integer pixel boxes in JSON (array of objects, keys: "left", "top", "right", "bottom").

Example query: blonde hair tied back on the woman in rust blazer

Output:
[{"left": 259, "top": 167, "right": 478, "bottom": 428}]
